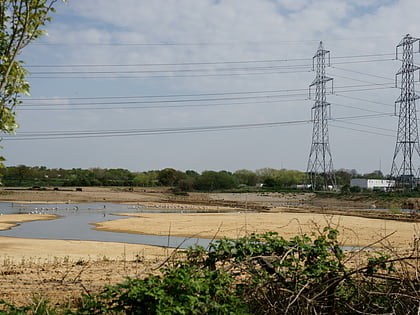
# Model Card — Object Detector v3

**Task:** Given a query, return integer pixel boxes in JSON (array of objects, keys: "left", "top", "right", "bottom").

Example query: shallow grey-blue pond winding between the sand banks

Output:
[{"left": 0, "top": 203, "right": 211, "bottom": 248}]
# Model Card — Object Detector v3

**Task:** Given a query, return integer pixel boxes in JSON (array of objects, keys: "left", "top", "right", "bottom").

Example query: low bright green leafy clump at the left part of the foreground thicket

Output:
[{"left": 75, "top": 262, "right": 246, "bottom": 314}]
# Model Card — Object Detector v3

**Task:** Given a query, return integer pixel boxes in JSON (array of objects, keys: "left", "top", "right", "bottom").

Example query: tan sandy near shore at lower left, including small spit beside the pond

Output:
[{"left": 0, "top": 214, "right": 173, "bottom": 306}]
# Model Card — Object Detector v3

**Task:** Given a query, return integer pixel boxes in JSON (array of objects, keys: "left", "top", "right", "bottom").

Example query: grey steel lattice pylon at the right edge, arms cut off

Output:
[{"left": 391, "top": 34, "right": 420, "bottom": 189}]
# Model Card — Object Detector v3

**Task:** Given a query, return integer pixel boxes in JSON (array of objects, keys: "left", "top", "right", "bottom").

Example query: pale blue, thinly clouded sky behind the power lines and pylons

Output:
[{"left": 2, "top": 0, "right": 420, "bottom": 174}]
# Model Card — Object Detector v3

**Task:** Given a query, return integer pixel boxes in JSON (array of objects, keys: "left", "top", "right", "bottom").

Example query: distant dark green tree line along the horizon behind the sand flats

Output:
[{"left": 0, "top": 165, "right": 383, "bottom": 191}]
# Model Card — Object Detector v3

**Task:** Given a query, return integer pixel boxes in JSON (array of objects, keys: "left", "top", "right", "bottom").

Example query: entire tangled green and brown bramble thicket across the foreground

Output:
[{"left": 0, "top": 227, "right": 420, "bottom": 314}]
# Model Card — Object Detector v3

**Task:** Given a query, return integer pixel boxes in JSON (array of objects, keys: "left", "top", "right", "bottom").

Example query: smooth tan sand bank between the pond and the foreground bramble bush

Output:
[{"left": 95, "top": 212, "right": 420, "bottom": 248}]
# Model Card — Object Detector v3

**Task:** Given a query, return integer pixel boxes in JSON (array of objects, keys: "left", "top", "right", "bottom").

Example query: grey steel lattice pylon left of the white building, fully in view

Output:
[{"left": 307, "top": 42, "right": 335, "bottom": 190}]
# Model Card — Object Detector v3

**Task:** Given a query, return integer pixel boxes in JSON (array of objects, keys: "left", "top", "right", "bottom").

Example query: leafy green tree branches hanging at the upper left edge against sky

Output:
[{"left": 0, "top": 0, "right": 66, "bottom": 161}]
